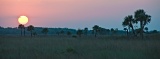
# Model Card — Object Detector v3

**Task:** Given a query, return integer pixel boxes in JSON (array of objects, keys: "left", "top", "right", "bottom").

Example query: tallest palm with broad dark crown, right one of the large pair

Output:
[{"left": 134, "top": 9, "right": 151, "bottom": 39}]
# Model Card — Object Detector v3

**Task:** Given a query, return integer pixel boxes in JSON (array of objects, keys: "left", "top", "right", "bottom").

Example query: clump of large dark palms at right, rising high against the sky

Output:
[{"left": 122, "top": 9, "right": 151, "bottom": 39}]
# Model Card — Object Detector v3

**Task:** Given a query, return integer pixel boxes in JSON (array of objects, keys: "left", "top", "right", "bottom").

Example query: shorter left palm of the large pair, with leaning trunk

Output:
[{"left": 122, "top": 15, "right": 136, "bottom": 36}]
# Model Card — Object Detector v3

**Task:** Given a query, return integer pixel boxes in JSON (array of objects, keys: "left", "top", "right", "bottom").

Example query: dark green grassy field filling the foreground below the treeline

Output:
[{"left": 0, "top": 35, "right": 160, "bottom": 59}]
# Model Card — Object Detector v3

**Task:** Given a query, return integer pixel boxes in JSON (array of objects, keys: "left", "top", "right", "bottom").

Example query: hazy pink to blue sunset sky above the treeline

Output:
[{"left": 0, "top": 0, "right": 160, "bottom": 30}]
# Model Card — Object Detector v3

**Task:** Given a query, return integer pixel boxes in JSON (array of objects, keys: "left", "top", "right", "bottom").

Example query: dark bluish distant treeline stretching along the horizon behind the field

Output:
[{"left": 0, "top": 27, "right": 158, "bottom": 36}]
